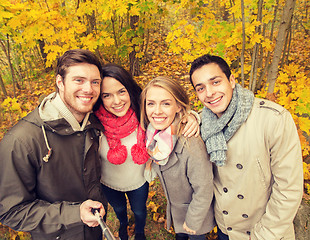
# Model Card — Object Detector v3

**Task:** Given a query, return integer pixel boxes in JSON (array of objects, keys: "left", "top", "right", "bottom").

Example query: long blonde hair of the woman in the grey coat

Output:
[{"left": 140, "top": 76, "right": 190, "bottom": 133}]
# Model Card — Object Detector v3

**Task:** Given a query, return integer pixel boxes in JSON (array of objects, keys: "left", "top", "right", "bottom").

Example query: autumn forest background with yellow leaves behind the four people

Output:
[{"left": 0, "top": 0, "right": 310, "bottom": 239}]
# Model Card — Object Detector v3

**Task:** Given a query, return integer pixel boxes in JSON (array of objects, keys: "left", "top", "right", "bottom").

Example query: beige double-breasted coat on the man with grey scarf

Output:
[{"left": 214, "top": 99, "right": 303, "bottom": 240}]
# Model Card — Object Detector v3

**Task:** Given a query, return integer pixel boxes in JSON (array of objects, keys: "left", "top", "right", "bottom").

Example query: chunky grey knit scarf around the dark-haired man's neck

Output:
[{"left": 201, "top": 84, "right": 254, "bottom": 167}]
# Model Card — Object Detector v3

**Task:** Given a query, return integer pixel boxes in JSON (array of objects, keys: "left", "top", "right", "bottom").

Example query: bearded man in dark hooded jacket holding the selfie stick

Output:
[{"left": 0, "top": 49, "right": 106, "bottom": 240}]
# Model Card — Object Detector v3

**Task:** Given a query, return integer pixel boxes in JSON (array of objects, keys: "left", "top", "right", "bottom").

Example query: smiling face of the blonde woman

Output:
[{"left": 145, "top": 86, "right": 181, "bottom": 130}]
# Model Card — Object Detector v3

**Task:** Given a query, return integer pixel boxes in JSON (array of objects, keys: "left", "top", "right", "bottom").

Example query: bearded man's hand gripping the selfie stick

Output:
[{"left": 80, "top": 199, "right": 105, "bottom": 227}]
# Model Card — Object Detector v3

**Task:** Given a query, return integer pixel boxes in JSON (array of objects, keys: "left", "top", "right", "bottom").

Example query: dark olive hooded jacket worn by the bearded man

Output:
[{"left": 0, "top": 96, "right": 106, "bottom": 240}]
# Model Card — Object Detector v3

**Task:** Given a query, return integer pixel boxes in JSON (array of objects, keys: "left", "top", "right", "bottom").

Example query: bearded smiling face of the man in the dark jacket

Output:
[{"left": 56, "top": 63, "right": 101, "bottom": 122}]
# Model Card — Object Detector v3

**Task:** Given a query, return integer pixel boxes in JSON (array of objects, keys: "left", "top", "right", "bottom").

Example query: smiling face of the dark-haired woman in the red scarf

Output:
[{"left": 101, "top": 77, "right": 131, "bottom": 117}]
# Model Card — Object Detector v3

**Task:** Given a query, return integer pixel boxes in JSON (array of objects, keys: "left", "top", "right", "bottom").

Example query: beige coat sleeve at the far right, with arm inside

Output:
[{"left": 251, "top": 110, "right": 303, "bottom": 240}]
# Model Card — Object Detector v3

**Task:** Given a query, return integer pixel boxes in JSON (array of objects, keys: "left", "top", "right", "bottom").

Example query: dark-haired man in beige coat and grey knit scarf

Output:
[{"left": 190, "top": 55, "right": 303, "bottom": 240}]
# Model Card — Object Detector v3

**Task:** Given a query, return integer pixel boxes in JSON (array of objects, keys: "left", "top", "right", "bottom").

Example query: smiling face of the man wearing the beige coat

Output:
[{"left": 192, "top": 63, "right": 236, "bottom": 117}]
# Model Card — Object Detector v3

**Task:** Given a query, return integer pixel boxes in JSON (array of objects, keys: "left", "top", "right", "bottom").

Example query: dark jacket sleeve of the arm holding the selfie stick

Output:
[{"left": 0, "top": 132, "right": 82, "bottom": 234}]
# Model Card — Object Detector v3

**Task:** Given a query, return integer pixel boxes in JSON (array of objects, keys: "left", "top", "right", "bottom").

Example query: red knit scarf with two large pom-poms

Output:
[{"left": 95, "top": 105, "right": 149, "bottom": 165}]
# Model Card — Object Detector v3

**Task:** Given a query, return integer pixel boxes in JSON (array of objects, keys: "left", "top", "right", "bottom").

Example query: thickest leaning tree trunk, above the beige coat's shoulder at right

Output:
[{"left": 267, "top": 0, "right": 296, "bottom": 94}]
